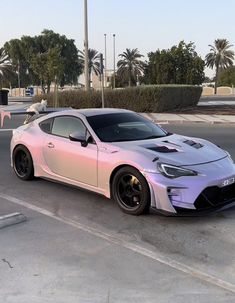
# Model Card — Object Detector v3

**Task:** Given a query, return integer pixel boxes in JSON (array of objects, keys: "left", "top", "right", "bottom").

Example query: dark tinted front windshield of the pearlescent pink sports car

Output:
[{"left": 87, "top": 113, "right": 168, "bottom": 142}]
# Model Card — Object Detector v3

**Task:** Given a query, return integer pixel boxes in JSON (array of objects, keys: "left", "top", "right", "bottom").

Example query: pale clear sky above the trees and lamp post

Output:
[{"left": 0, "top": 0, "right": 235, "bottom": 77}]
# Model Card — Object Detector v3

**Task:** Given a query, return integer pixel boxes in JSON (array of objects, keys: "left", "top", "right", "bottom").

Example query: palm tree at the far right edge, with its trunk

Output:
[{"left": 206, "top": 39, "right": 234, "bottom": 94}]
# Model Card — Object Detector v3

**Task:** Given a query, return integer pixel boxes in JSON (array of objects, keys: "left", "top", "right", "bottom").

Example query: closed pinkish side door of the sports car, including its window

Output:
[{"left": 40, "top": 115, "right": 98, "bottom": 186}]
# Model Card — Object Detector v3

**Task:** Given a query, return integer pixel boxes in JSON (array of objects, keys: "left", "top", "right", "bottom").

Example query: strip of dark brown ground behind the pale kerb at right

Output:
[{"left": 171, "top": 105, "right": 235, "bottom": 115}]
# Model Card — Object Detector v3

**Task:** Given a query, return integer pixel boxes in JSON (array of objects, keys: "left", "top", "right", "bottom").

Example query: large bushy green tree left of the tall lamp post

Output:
[{"left": 4, "top": 30, "right": 82, "bottom": 90}]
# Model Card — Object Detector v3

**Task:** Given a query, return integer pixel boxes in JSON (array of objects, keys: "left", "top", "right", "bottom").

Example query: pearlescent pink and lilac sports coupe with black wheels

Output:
[{"left": 11, "top": 109, "right": 235, "bottom": 215}]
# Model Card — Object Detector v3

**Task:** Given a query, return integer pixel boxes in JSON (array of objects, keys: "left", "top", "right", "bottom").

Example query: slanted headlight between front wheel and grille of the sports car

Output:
[{"left": 157, "top": 163, "right": 198, "bottom": 178}]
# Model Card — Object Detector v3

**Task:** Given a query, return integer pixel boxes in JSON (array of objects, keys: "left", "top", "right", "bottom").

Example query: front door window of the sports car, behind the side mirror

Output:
[{"left": 51, "top": 116, "right": 86, "bottom": 138}]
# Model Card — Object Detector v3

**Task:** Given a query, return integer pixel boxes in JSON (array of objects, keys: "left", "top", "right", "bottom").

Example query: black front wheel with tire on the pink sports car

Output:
[{"left": 111, "top": 166, "right": 150, "bottom": 216}]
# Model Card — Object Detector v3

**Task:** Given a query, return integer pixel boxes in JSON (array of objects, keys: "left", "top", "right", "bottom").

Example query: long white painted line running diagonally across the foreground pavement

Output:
[{"left": 0, "top": 193, "right": 235, "bottom": 293}]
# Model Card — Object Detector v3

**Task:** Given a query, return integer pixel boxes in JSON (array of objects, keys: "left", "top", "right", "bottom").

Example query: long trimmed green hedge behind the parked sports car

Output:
[{"left": 34, "top": 85, "right": 202, "bottom": 112}]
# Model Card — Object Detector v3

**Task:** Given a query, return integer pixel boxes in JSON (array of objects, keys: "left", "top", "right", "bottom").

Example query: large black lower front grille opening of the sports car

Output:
[{"left": 194, "top": 183, "right": 235, "bottom": 210}]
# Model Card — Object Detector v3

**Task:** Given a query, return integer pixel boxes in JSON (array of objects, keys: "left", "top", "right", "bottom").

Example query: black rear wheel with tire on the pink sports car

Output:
[{"left": 13, "top": 145, "right": 34, "bottom": 181}]
